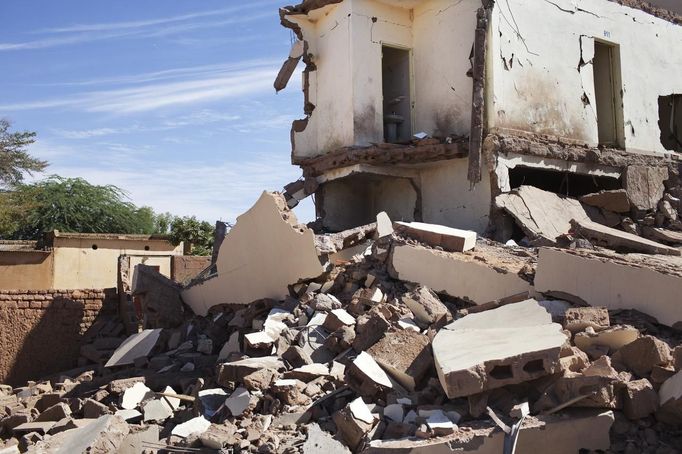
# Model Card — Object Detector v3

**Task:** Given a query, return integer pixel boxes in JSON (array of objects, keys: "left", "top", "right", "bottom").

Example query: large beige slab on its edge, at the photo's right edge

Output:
[{"left": 535, "top": 248, "right": 682, "bottom": 326}]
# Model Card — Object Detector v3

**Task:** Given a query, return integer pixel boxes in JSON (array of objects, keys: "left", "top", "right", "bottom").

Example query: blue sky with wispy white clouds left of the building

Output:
[{"left": 0, "top": 0, "right": 313, "bottom": 222}]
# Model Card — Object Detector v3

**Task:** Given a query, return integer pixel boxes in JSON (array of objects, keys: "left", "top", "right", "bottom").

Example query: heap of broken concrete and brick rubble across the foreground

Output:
[{"left": 0, "top": 192, "right": 682, "bottom": 454}]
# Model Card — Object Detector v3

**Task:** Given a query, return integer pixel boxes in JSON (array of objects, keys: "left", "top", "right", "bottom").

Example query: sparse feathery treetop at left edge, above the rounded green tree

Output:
[{"left": 0, "top": 118, "right": 47, "bottom": 187}]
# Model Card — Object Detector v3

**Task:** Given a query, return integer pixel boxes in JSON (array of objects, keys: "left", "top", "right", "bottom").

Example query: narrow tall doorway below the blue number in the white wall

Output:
[{"left": 593, "top": 41, "right": 625, "bottom": 148}]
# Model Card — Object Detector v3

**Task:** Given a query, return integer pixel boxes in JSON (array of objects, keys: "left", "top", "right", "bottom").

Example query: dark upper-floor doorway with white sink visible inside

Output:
[{"left": 381, "top": 46, "right": 412, "bottom": 143}]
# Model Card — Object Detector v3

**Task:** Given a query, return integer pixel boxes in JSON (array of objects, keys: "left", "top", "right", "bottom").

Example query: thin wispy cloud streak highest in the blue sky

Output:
[{"left": 0, "top": 0, "right": 279, "bottom": 51}]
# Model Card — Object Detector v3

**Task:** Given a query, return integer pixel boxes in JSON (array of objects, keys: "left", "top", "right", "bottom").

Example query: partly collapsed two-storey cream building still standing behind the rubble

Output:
[{"left": 275, "top": 0, "right": 682, "bottom": 240}]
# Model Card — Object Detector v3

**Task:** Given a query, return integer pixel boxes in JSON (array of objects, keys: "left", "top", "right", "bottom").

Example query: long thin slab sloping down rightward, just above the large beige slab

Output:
[{"left": 571, "top": 219, "right": 682, "bottom": 255}]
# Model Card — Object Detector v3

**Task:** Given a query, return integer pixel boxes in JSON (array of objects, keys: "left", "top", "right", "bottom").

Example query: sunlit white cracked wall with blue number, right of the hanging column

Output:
[{"left": 488, "top": 0, "right": 682, "bottom": 152}]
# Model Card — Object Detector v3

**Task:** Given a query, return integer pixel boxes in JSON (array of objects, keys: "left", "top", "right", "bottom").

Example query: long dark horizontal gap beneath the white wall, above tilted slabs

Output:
[{"left": 509, "top": 166, "right": 622, "bottom": 197}]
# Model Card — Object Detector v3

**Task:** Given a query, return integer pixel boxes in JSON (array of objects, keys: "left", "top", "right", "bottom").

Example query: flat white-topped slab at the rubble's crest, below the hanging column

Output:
[{"left": 393, "top": 221, "right": 476, "bottom": 252}]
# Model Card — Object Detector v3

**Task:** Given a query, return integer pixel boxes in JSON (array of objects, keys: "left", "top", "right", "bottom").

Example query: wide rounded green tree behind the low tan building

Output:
[{"left": 0, "top": 176, "right": 154, "bottom": 239}]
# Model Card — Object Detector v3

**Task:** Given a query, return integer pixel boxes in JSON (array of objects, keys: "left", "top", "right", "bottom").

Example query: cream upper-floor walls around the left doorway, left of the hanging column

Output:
[{"left": 288, "top": 0, "right": 480, "bottom": 158}]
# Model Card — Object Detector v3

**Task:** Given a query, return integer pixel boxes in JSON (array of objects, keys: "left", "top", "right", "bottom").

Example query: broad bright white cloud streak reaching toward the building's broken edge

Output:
[{"left": 0, "top": 64, "right": 277, "bottom": 114}]
